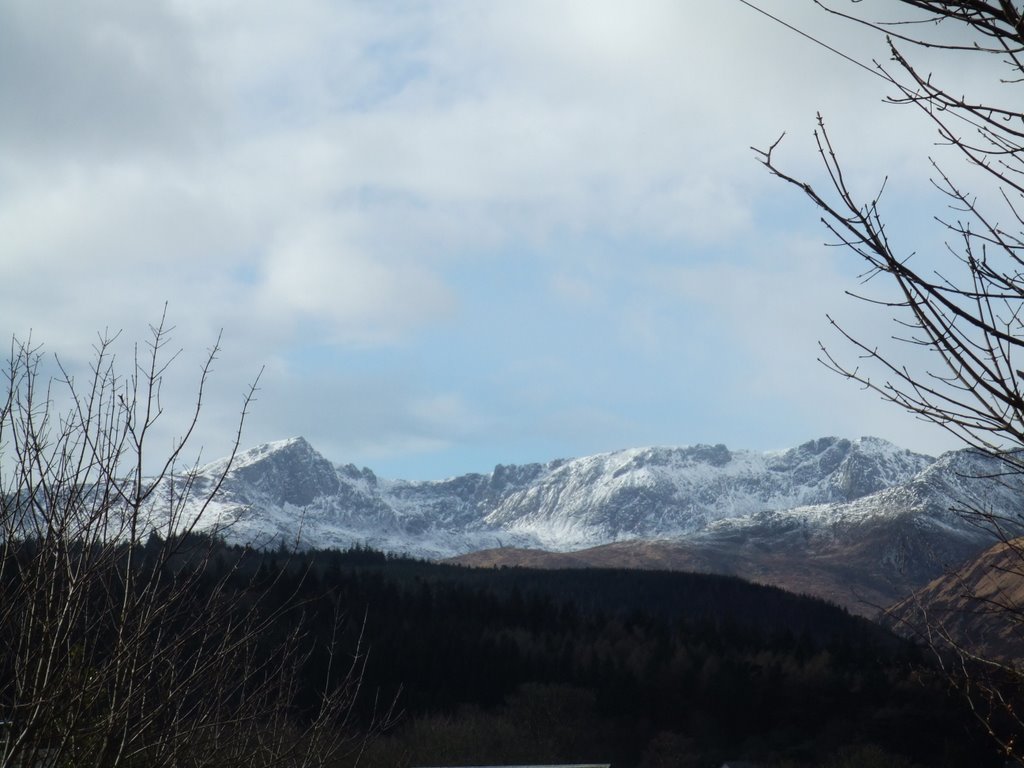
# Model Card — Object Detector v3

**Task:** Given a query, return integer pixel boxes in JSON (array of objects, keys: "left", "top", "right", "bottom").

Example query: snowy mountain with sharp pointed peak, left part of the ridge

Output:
[{"left": 168, "top": 437, "right": 544, "bottom": 557}]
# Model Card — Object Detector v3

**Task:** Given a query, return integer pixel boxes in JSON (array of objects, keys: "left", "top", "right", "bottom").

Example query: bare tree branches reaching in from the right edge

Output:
[{"left": 755, "top": 0, "right": 1024, "bottom": 764}]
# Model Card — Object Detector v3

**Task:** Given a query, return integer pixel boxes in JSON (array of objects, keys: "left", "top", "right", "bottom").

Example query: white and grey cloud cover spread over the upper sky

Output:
[{"left": 0, "top": 0, "right": 991, "bottom": 475}]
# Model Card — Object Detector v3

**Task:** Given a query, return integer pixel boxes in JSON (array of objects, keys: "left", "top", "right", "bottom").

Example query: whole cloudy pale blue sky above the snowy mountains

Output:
[{"left": 0, "top": 0, "right": 978, "bottom": 479}]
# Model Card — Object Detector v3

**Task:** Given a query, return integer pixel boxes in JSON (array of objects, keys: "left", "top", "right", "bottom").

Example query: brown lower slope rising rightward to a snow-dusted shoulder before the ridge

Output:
[{"left": 456, "top": 446, "right": 1024, "bottom": 615}]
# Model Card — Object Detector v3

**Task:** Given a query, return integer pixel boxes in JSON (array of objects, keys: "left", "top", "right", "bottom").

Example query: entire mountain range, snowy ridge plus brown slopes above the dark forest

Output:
[{"left": 161, "top": 437, "right": 1024, "bottom": 613}]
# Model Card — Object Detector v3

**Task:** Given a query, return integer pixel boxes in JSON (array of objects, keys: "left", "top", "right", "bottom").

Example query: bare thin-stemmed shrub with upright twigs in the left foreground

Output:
[{"left": 0, "top": 319, "right": 374, "bottom": 768}]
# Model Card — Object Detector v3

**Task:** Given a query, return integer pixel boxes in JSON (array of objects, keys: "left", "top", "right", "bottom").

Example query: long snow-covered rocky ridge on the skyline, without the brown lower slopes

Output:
[{"left": 159, "top": 437, "right": 950, "bottom": 557}]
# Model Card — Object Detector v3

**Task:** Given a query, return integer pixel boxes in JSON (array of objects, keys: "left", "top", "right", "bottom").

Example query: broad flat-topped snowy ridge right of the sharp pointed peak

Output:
[{"left": 486, "top": 437, "right": 934, "bottom": 549}]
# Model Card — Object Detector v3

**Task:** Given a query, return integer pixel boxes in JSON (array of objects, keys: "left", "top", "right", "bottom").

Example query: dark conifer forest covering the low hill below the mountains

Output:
[{"left": 0, "top": 537, "right": 999, "bottom": 768}]
